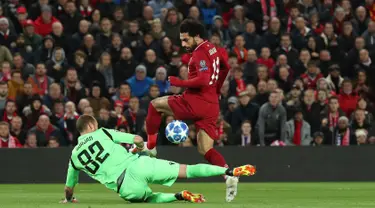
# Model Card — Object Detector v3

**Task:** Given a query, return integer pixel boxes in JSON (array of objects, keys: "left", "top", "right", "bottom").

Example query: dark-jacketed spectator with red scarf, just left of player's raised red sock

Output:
[{"left": 124, "top": 97, "right": 147, "bottom": 134}]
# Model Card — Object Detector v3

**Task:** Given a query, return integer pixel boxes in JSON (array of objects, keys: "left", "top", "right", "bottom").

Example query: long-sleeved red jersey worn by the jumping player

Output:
[{"left": 170, "top": 41, "right": 229, "bottom": 103}]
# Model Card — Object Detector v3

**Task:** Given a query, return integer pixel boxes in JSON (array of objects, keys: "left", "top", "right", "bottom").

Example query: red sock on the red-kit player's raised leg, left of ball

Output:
[{"left": 146, "top": 103, "right": 161, "bottom": 149}]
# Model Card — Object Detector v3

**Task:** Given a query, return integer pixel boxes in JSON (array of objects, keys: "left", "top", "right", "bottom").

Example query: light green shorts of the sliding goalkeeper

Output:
[{"left": 119, "top": 156, "right": 180, "bottom": 202}]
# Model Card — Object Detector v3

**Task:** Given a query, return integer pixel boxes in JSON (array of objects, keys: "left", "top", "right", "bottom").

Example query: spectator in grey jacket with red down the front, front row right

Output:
[{"left": 285, "top": 109, "right": 311, "bottom": 146}]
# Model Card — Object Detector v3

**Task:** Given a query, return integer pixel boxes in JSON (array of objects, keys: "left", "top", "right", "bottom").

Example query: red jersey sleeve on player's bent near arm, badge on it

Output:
[{"left": 169, "top": 51, "right": 213, "bottom": 88}]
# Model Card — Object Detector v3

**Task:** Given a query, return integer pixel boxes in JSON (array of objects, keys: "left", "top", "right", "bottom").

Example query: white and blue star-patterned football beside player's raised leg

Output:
[{"left": 165, "top": 121, "right": 189, "bottom": 144}]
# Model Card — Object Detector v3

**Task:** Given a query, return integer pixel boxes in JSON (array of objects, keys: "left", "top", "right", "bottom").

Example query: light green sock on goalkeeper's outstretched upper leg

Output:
[{"left": 186, "top": 164, "right": 228, "bottom": 178}]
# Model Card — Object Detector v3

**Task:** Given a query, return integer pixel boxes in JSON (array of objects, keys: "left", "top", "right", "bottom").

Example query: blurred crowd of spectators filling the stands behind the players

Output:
[{"left": 0, "top": 0, "right": 375, "bottom": 148}]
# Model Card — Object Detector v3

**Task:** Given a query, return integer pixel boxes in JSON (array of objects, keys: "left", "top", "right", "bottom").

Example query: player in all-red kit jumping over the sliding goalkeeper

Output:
[{"left": 140, "top": 19, "right": 251, "bottom": 202}]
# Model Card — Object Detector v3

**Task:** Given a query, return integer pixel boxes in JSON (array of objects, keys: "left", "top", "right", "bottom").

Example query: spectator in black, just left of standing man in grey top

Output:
[{"left": 230, "top": 91, "right": 259, "bottom": 133}]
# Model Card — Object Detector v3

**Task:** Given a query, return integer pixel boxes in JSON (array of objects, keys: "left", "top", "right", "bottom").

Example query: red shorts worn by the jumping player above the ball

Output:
[{"left": 168, "top": 95, "right": 220, "bottom": 140}]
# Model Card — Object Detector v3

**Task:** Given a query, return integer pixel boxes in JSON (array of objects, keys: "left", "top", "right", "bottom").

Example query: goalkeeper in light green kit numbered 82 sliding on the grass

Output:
[{"left": 62, "top": 115, "right": 255, "bottom": 203}]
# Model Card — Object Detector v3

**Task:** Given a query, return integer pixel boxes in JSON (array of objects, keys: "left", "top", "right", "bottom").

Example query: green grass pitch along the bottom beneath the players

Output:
[{"left": 0, "top": 183, "right": 375, "bottom": 208}]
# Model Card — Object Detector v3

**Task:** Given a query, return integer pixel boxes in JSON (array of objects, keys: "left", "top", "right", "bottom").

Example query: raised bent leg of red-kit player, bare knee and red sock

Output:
[{"left": 146, "top": 96, "right": 173, "bottom": 149}]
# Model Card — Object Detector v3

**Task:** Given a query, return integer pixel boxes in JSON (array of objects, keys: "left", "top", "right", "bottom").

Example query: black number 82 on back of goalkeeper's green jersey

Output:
[{"left": 77, "top": 141, "right": 109, "bottom": 174}]
